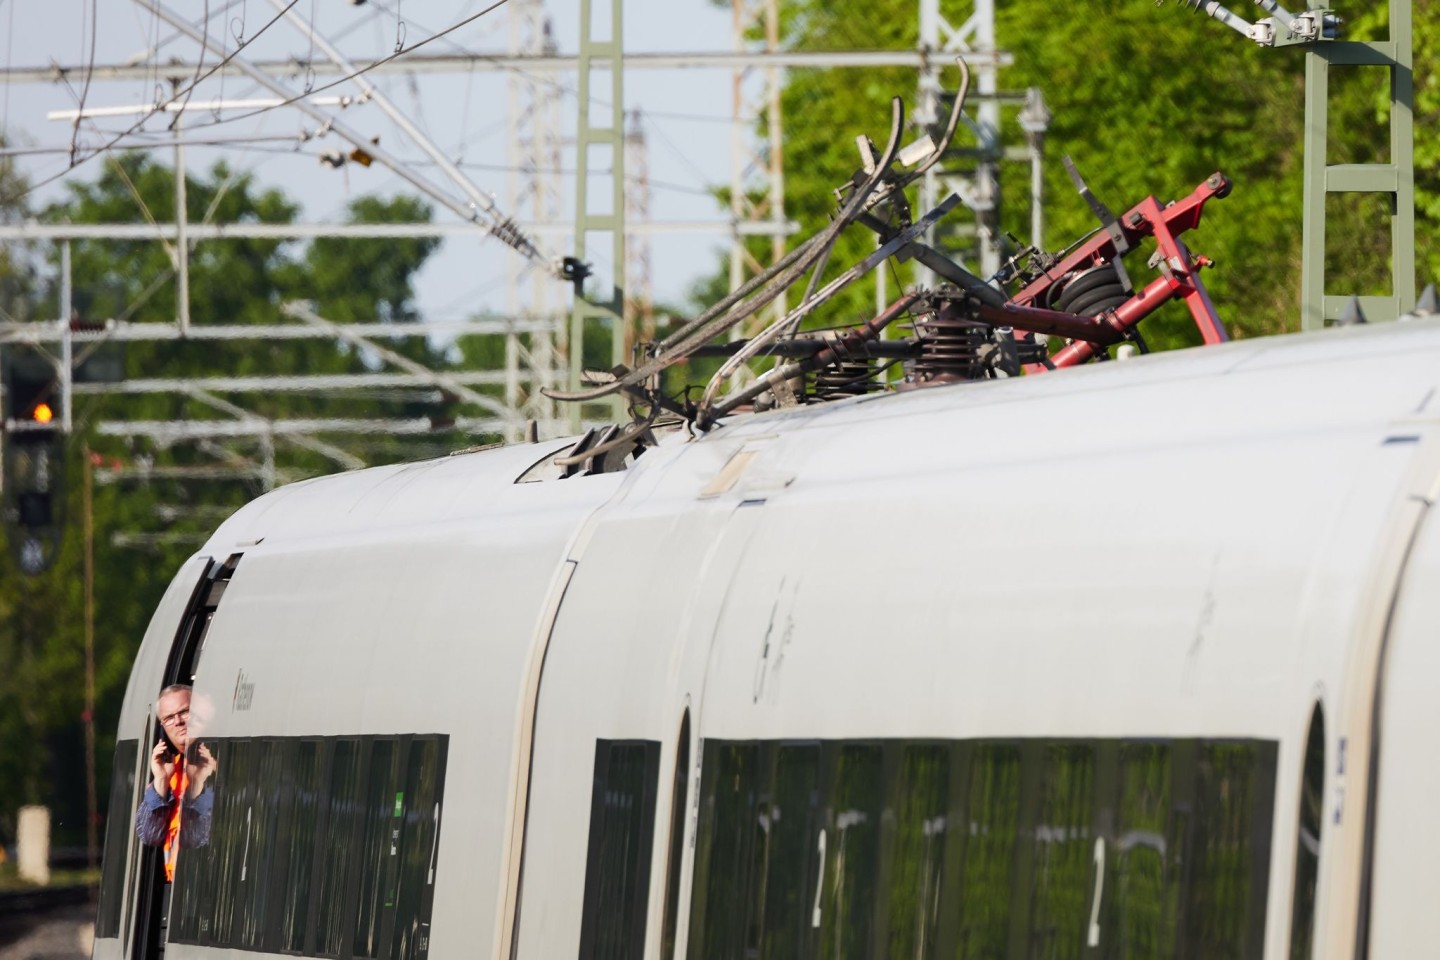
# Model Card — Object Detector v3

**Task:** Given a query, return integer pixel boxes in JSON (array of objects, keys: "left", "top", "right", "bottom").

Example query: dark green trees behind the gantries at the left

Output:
[{"left": 0, "top": 154, "right": 451, "bottom": 845}]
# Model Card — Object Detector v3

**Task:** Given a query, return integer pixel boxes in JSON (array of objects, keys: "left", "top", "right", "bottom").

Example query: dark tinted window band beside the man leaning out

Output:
[{"left": 170, "top": 735, "right": 448, "bottom": 960}]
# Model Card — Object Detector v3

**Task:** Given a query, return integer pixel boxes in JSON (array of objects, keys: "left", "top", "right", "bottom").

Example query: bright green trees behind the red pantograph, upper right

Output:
[{"left": 707, "top": 0, "right": 1440, "bottom": 356}]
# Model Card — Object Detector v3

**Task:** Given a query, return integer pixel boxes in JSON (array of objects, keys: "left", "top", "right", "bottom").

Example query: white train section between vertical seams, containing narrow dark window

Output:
[{"left": 503, "top": 499, "right": 763, "bottom": 960}]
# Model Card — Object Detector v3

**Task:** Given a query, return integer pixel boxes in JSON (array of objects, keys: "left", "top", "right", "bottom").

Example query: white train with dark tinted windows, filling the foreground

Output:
[{"left": 94, "top": 318, "right": 1440, "bottom": 960}]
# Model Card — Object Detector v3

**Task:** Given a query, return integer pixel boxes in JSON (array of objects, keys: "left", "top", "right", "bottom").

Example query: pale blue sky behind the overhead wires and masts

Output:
[{"left": 0, "top": 0, "right": 755, "bottom": 321}]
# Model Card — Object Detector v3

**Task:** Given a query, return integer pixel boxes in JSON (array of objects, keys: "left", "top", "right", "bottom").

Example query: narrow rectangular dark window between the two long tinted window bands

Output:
[{"left": 580, "top": 740, "right": 660, "bottom": 960}]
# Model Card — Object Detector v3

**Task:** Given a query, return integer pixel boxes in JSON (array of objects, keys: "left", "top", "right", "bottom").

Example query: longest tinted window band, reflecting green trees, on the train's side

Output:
[{"left": 688, "top": 740, "right": 1276, "bottom": 960}]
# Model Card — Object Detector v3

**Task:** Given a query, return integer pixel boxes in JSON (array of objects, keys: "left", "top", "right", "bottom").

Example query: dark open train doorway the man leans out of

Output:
[{"left": 130, "top": 554, "right": 240, "bottom": 960}]
